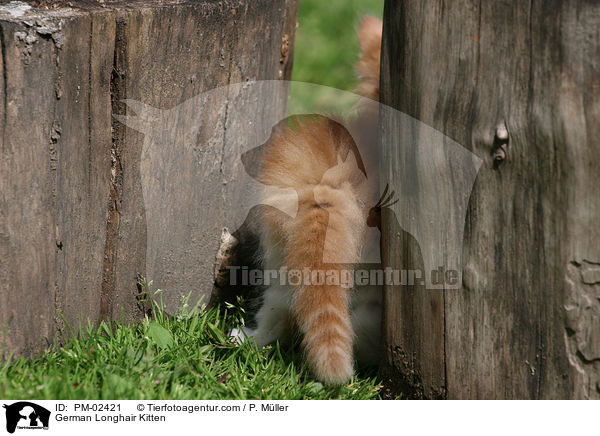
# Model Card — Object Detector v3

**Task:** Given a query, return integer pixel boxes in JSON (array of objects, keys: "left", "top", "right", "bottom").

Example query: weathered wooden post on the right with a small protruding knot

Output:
[{"left": 382, "top": 0, "right": 600, "bottom": 399}]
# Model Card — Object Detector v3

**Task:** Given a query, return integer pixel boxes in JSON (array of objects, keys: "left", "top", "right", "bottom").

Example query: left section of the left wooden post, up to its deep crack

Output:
[{"left": 0, "top": 10, "right": 114, "bottom": 354}]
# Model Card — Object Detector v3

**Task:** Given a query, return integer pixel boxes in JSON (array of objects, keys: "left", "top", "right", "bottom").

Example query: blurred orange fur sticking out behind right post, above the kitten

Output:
[{"left": 356, "top": 16, "right": 383, "bottom": 100}]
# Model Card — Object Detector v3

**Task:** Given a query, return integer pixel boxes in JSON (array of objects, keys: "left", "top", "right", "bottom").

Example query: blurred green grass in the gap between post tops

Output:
[{"left": 290, "top": 0, "right": 383, "bottom": 112}]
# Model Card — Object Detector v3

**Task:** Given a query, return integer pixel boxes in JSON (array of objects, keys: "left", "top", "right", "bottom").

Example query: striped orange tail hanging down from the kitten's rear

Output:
[{"left": 285, "top": 189, "right": 356, "bottom": 384}]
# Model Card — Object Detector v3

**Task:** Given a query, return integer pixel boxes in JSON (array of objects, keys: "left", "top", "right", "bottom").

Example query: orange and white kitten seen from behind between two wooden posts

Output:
[{"left": 232, "top": 17, "right": 381, "bottom": 384}]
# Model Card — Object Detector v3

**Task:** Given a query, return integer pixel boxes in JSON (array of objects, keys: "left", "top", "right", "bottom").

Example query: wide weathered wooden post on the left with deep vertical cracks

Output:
[{"left": 0, "top": 0, "right": 296, "bottom": 353}]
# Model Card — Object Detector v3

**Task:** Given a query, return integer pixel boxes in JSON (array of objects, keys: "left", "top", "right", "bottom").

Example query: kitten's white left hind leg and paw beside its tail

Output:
[{"left": 229, "top": 286, "right": 291, "bottom": 348}]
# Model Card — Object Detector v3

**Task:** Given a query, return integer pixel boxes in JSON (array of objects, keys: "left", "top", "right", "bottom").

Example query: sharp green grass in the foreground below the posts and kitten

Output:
[{"left": 0, "top": 288, "right": 380, "bottom": 400}]
